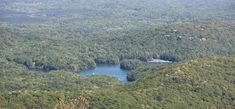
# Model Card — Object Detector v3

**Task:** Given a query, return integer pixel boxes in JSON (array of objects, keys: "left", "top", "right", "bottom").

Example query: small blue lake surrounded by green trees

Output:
[{"left": 80, "top": 64, "right": 128, "bottom": 83}]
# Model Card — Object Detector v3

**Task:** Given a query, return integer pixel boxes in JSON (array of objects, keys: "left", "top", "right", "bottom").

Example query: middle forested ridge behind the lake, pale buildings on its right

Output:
[{"left": 0, "top": 22, "right": 235, "bottom": 72}]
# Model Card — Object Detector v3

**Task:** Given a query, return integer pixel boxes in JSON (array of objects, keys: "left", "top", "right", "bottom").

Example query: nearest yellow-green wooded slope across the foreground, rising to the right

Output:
[{"left": 0, "top": 57, "right": 235, "bottom": 109}]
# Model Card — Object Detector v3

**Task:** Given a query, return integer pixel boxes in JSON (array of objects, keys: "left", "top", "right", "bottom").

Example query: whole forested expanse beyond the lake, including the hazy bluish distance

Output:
[{"left": 0, "top": 0, "right": 235, "bottom": 72}]
